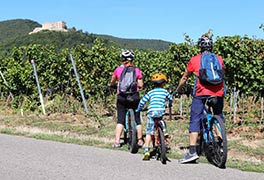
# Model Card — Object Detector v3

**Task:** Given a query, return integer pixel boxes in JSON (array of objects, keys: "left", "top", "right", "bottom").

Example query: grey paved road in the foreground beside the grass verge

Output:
[{"left": 0, "top": 134, "right": 264, "bottom": 180}]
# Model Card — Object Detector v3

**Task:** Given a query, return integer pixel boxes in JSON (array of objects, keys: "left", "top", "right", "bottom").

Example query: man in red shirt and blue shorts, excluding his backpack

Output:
[{"left": 177, "top": 34, "right": 225, "bottom": 163}]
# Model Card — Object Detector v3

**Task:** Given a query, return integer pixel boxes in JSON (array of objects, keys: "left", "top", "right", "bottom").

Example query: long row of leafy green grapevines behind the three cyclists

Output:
[{"left": 0, "top": 36, "right": 264, "bottom": 111}]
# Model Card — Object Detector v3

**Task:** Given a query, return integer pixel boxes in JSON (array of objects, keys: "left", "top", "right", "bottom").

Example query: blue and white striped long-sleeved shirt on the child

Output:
[{"left": 138, "top": 88, "right": 172, "bottom": 112}]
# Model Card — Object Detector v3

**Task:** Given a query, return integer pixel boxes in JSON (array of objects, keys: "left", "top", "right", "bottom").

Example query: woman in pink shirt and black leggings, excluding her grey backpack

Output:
[{"left": 110, "top": 50, "right": 143, "bottom": 147}]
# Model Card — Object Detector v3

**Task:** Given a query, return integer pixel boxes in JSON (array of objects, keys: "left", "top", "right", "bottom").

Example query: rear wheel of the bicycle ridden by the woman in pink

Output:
[{"left": 128, "top": 109, "right": 138, "bottom": 154}]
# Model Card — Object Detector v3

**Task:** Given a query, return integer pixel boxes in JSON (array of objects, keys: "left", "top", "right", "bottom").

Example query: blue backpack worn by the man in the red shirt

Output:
[{"left": 199, "top": 52, "right": 224, "bottom": 85}]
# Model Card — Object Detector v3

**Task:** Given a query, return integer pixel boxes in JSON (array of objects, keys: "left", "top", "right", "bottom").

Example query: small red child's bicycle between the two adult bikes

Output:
[{"left": 142, "top": 108, "right": 171, "bottom": 164}]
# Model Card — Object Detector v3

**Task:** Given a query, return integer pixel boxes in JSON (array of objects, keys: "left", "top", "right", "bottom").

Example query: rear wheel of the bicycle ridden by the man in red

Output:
[{"left": 208, "top": 115, "right": 227, "bottom": 168}]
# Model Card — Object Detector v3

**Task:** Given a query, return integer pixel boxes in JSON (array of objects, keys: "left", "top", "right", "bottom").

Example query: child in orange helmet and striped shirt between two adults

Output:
[{"left": 137, "top": 73, "right": 172, "bottom": 160}]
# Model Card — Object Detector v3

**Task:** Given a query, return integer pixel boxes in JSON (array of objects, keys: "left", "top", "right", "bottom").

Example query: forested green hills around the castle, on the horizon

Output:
[{"left": 0, "top": 19, "right": 171, "bottom": 51}]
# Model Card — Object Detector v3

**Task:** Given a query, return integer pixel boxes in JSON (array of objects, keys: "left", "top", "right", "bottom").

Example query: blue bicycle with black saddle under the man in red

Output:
[{"left": 197, "top": 96, "right": 227, "bottom": 168}]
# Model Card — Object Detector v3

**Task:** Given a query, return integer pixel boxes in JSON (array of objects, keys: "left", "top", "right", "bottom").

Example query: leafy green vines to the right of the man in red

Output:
[{"left": 214, "top": 36, "right": 264, "bottom": 93}]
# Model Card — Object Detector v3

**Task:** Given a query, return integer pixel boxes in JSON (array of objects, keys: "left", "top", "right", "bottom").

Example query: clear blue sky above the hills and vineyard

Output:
[{"left": 0, "top": 0, "right": 264, "bottom": 43}]
